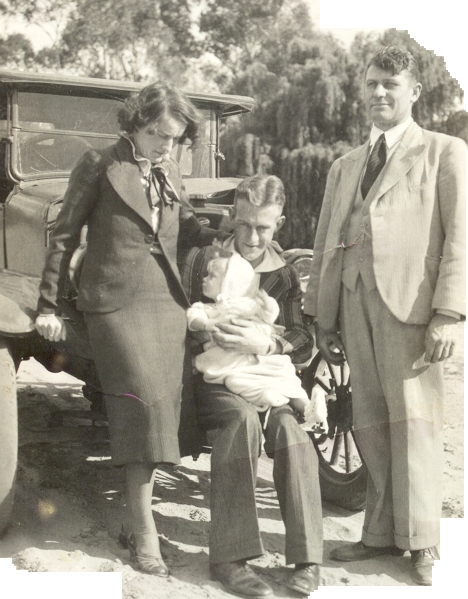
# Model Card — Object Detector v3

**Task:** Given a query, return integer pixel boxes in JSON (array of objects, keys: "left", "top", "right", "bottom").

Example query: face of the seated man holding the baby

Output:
[{"left": 232, "top": 200, "right": 285, "bottom": 268}]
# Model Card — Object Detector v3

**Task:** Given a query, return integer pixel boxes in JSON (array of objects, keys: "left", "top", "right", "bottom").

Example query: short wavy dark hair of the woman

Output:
[{"left": 117, "top": 83, "right": 202, "bottom": 145}]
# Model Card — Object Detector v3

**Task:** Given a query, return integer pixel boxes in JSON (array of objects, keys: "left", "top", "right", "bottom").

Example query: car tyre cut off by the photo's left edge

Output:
[{"left": 0, "top": 338, "right": 18, "bottom": 535}]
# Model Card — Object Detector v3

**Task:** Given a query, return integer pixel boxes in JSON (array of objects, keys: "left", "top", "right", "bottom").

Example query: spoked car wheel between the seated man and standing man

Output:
[{"left": 302, "top": 353, "right": 367, "bottom": 510}]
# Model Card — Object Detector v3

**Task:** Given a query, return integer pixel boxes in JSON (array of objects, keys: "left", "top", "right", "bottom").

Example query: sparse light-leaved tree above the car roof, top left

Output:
[{"left": 0, "top": 0, "right": 200, "bottom": 84}]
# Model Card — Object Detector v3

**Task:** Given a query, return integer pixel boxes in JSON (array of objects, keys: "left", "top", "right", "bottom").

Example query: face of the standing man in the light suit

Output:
[{"left": 365, "top": 65, "right": 421, "bottom": 131}]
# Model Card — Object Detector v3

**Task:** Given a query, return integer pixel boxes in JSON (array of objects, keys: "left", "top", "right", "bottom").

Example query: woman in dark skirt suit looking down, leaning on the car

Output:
[{"left": 36, "top": 84, "right": 214, "bottom": 576}]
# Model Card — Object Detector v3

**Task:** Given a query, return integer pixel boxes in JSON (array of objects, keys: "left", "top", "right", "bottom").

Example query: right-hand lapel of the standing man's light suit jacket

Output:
[{"left": 368, "top": 123, "right": 425, "bottom": 202}]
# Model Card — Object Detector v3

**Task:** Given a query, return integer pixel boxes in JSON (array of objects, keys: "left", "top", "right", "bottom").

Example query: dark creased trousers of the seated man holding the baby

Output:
[{"left": 196, "top": 377, "right": 323, "bottom": 564}]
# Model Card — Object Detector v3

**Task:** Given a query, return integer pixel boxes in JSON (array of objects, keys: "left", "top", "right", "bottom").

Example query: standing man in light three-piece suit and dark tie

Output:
[{"left": 304, "top": 47, "right": 466, "bottom": 585}]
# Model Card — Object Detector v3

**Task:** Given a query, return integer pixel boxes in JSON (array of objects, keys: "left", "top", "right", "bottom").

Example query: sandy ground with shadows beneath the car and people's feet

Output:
[{"left": 0, "top": 325, "right": 463, "bottom": 599}]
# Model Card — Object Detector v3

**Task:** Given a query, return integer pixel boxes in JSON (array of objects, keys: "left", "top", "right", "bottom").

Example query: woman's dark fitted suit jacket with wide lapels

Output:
[{"left": 38, "top": 138, "right": 216, "bottom": 313}]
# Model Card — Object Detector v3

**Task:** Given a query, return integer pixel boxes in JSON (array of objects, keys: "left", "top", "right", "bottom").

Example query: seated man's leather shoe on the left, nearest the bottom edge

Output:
[{"left": 210, "top": 560, "right": 273, "bottom": 599}]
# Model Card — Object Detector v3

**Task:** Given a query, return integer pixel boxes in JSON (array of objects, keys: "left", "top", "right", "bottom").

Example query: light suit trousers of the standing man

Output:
[{"left": 341, "top": 278, "right": 443, "bottom": 550}]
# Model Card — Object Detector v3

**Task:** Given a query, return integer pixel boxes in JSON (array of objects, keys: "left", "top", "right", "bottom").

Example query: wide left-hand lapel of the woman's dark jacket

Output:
[{"left": 107, "top": 138, "right": 153, "bottom": 228}]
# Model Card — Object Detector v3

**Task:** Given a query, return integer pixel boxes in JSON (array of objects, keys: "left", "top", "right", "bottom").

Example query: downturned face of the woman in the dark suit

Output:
[{"left": 131, "top": 113, "right": 187, "bottom": 164}]
